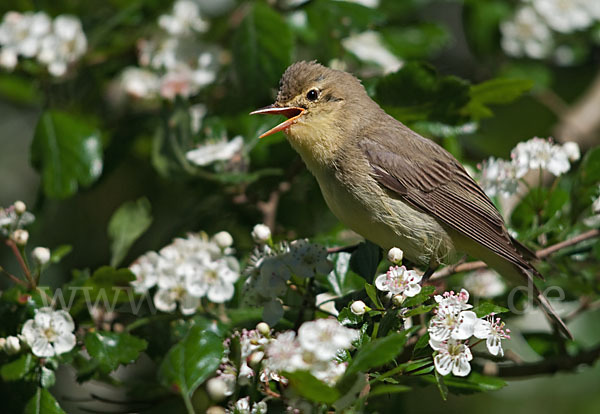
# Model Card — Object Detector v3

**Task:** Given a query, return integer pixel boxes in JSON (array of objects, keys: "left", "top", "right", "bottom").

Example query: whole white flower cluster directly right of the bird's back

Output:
[{"left": 478, "top": 137, "right": 580, "bottom": 197}]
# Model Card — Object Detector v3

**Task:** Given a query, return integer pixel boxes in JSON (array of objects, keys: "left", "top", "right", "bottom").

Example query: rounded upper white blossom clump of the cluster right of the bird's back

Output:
[{"left": 510, "top": 137, "right": 571, "bottom": 178}]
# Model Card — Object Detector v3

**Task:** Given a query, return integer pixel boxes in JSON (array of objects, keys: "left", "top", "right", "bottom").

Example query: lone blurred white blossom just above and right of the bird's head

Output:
[{"left": 342, "top": 30, "right": 403, "bottom": 74}]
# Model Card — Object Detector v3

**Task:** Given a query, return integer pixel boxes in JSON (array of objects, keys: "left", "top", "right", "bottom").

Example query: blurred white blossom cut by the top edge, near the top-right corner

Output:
[{"left": 532, "top": 0, "right": 597, "bottom": 33}]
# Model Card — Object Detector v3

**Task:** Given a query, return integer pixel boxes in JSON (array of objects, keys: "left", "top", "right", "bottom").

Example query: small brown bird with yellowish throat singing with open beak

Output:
[{"left": 252, "top": 62, "right": 572, "bottom": 338}]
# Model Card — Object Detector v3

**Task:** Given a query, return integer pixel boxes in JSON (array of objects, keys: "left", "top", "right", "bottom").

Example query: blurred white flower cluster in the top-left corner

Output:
[{"left": 0, "top": 11, "right": 87, "bottom": 77}]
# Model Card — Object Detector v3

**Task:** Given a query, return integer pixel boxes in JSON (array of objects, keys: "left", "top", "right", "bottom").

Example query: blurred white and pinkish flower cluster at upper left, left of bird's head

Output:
[{"left": 120, "top": 0, "right": 219, "bottom": 101}]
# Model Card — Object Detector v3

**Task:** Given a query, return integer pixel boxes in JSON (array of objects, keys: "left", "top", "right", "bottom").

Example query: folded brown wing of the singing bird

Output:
[{"left": 359, "top": 128, "right": 542, "bottom": 277}]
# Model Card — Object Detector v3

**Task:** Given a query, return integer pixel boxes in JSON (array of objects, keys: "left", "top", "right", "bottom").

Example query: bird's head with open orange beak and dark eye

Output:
[{"left": 252, "top": 61, "right": 372, "bottom": 151}]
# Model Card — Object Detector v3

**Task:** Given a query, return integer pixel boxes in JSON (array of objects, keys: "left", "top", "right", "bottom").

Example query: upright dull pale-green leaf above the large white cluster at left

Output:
[{"left": 108, "top": 197, "right": 152, "bottom": 267}]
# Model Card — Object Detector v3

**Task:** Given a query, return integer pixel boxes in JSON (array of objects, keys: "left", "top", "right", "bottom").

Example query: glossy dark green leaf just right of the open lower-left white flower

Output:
[{"left": 84, "top": 331, "right": 148, "bottom": 373}]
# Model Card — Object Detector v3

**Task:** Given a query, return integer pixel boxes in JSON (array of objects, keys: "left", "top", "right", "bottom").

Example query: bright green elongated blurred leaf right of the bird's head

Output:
[{"left": 462, "top": 78, "right": 533, "bottom": 119}]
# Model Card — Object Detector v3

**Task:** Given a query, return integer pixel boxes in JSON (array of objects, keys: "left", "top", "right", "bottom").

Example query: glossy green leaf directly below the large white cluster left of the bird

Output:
[{"left": 158, "top": 326, "right": 224, "bottom": 398}]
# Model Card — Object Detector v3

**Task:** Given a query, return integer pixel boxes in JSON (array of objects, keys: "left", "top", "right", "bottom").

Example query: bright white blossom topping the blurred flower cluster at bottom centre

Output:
[{"left": 298, "top": 319, "right": 358, "bottom": 361}]
